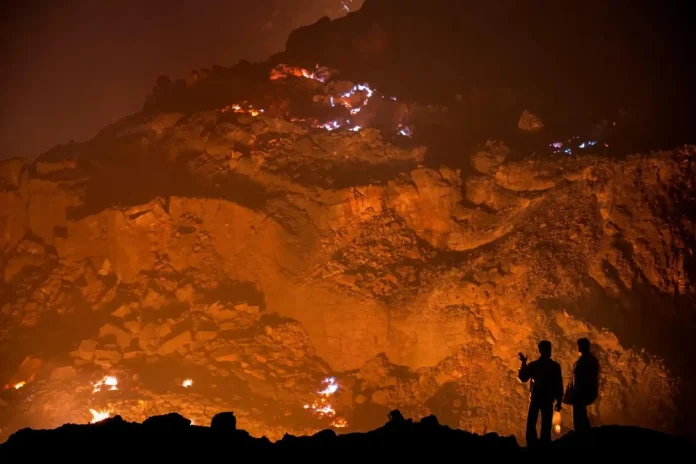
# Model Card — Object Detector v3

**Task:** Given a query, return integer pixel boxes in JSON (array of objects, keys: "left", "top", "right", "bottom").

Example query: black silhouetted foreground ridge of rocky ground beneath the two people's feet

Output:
[{"left": 0, "top": 410, "right": 692, "bottom": 456}]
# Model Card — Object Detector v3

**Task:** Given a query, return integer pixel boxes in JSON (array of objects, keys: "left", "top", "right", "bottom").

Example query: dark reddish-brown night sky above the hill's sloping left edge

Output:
[{"left": 0, "top": 0, "right": 362, "bottom": 159}]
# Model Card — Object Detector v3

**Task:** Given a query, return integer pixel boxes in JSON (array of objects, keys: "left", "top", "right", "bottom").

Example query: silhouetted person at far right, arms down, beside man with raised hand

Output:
[{"left": 571, "top": 338, "right": 599, "bottom": 432}]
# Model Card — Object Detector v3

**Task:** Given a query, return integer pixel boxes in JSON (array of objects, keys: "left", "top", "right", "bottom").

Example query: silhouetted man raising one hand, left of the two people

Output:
[{"left": 517, "top": 340, "right": 563, "bottom": 446}]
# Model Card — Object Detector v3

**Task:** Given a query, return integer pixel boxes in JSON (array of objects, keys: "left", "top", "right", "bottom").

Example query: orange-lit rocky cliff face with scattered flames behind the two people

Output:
[{"left": 0, "top": 2, "right": 696, "bottom": 437}]
